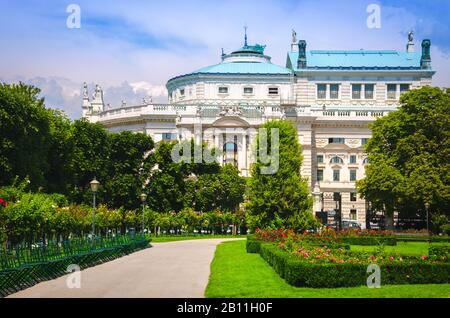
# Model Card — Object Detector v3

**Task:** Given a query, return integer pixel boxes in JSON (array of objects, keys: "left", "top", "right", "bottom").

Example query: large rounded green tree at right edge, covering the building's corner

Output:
[{"left": 357, "top": 87, "right": 450, "bottom": 227}]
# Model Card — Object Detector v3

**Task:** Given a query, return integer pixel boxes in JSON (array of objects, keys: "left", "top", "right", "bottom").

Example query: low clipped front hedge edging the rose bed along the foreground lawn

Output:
[{"left": 255, "top": 243, "right": 450, "bottom": 288}]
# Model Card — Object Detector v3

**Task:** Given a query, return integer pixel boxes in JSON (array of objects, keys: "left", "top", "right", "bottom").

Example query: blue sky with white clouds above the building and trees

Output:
[{"left": 0, "top": 0, "right": 450, "bottom": 119}]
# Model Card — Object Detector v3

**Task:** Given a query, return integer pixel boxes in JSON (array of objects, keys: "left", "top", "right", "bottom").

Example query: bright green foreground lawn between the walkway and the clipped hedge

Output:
[{"left": 205, "top": 240, "right": 450, "bottom": 298}]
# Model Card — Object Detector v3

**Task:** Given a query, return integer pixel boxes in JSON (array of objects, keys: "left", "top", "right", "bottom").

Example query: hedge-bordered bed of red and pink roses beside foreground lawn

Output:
[{"left": 247, "top": 230, "right": 450, "bottom": 288}]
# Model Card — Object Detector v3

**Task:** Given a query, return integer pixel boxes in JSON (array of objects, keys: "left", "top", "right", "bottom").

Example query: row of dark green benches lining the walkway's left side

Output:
[{"left": 0, "top": 235, "right": 150, "bottom": 297}]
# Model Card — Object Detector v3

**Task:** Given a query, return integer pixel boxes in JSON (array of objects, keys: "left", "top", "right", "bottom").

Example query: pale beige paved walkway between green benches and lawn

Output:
[{"left": 9, "top": 239, "right": 243, "bottom": 298}]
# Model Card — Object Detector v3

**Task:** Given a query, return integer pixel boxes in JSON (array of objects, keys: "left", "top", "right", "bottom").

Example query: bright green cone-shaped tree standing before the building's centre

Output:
[{"left": 246, "top": 121, "right": 317, "bottom": 230}]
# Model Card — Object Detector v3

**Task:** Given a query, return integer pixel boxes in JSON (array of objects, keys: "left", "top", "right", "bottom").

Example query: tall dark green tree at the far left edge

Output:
[{"left": 0, "top": 83, "right": 51, "bottom": 189}]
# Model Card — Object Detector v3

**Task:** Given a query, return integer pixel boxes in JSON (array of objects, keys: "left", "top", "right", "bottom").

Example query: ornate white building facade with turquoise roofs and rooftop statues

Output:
[{"left": 82, "top": 32, "right": 434, "bottom": 228}]
